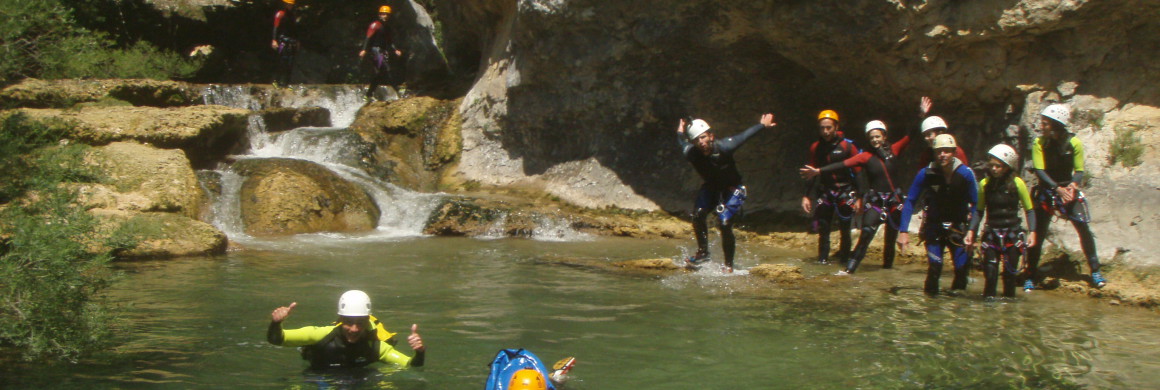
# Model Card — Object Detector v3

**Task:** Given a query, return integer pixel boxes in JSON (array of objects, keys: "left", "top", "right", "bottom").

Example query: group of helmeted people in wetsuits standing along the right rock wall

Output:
[{"left": 677, "top": 98, "right": 1107, "bottom": 297}]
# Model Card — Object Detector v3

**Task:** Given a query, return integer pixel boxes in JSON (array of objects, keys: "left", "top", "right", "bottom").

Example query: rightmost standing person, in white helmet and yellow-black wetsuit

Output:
[{"left": 1023, "top": 104, "right": 1108, "bottom": 291}]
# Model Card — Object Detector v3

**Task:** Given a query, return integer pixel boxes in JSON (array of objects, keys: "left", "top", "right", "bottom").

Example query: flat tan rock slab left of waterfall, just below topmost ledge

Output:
[{"left": 21, "top": 106, "right": 249, "bottom": 166}]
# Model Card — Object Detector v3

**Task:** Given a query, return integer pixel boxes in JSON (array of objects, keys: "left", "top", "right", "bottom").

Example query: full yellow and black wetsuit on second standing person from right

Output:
[{"left": 971, "top": 174, "right": 1036, "bottom": 297}]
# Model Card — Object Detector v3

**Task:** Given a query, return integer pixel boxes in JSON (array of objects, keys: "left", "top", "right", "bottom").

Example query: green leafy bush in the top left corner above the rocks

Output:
[{"left": 0, "top": 0, "right": 201, "bottom": 81}]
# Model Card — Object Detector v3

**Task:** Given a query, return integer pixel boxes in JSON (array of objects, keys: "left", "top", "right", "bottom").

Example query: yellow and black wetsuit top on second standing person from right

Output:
[{"left": 971, "top": 173, "right": 1035, "bottom": 232}]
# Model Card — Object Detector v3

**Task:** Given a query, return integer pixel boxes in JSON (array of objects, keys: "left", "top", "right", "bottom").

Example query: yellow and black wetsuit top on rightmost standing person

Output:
[{"left": 1031, "top": 135, "right": 1083, "bottom": 188}]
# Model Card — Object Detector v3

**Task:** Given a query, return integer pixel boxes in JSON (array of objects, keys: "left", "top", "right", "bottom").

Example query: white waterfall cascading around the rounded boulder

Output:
[{"left": 202, "top": 86, "right": 442, "bottom": 240}]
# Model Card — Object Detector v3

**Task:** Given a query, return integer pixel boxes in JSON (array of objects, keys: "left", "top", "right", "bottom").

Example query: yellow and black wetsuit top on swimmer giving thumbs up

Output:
[{"left": 266, "top": 323, "right": 423, "bottom": 369}]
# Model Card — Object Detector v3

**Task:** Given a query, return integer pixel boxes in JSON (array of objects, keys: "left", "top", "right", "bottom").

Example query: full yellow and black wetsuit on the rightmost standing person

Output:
[{"left": 1027, "top": 135, "right": 1100, "bottom": 283}]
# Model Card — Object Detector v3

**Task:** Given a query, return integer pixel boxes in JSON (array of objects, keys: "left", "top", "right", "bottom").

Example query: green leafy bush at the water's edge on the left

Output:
[{"left": 0, "top": 114, "right": 133, "bottom": 360}]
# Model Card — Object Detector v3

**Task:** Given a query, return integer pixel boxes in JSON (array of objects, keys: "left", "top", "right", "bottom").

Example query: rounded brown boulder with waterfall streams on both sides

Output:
[{"left": 233, "top": 159, "right": 379, "bottom": 236}]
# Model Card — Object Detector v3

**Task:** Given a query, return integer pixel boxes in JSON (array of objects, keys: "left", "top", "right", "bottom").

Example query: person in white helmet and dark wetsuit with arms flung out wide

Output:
[{"left": 676, "top": 114, "right": 777, "bottom": 273}]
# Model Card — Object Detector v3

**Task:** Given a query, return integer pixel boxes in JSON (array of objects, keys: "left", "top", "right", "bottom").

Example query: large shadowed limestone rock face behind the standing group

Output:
[{"left": 437, "top": 0, "right": 1160, "bottom": 264}]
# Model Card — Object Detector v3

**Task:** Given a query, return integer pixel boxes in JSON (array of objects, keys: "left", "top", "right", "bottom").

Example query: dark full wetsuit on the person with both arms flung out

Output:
[{"left": 676, "top": 124, "right": 764, "bottom": 268}]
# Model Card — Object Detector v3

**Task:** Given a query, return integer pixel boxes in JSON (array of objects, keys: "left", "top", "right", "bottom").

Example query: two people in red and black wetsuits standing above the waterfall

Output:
[{"left": 270, "top": 0, "right": 403, "bottom": 100}]
